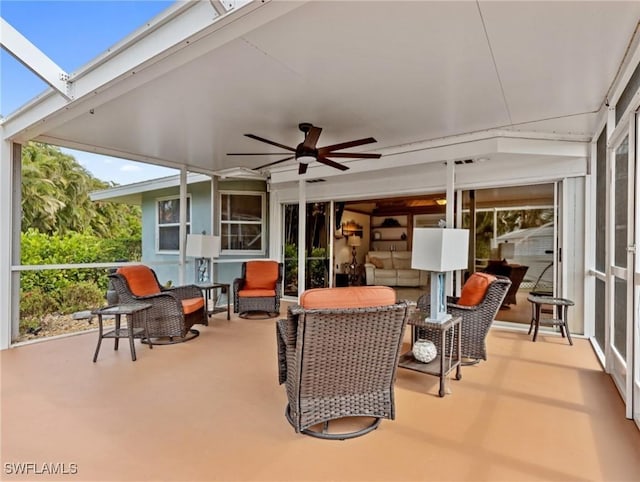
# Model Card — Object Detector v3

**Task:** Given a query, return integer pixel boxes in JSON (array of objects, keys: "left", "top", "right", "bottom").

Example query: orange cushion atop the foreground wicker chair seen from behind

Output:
[{"left": 300, "top": 286, "right": 396, "bottom": 309}]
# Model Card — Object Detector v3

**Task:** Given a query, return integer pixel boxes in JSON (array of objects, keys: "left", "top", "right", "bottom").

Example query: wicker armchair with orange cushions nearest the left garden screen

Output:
[{"left": 109, "top": 265, "right": 208, "bottom": 344}]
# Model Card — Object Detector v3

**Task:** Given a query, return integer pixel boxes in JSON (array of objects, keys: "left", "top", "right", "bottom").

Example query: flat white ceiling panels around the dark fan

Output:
[{"left": 31, "top": 1, "right": 640, "bottom": 177}]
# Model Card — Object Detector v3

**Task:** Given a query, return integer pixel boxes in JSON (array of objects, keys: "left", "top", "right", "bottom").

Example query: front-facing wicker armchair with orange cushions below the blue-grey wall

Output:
[{"left": 233, "top": 260, "right": 282, "bottom": 318}]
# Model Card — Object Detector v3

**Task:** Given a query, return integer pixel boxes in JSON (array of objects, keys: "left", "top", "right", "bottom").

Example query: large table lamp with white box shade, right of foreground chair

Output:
[{"left": 411, "top": 228, "right": 469, "bottom": 323}]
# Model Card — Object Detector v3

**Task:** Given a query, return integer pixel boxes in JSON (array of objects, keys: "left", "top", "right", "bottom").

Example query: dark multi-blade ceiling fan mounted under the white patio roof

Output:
[{"left": 227, "top": 122, "right": 381, "bottom": 174}]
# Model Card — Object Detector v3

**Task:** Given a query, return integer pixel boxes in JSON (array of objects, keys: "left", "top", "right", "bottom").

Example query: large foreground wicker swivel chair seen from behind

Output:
[{"left": 276, "top": 286, "right": 408, "bottom": 440}]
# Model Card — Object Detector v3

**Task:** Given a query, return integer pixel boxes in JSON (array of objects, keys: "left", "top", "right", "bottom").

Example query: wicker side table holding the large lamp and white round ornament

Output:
[{"left": 398, "top": 309, "right": 462, "bottom": 397}]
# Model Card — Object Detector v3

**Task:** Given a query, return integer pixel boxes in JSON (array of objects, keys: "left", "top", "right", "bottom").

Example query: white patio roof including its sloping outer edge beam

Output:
[{"left": 3, "top": 0, "right": 640, "bottom": 183}]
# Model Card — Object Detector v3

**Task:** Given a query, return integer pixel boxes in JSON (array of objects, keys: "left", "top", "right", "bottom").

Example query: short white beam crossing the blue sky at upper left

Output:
[{"left": 0, "top": 17, "right": 73, "bottom": 100}]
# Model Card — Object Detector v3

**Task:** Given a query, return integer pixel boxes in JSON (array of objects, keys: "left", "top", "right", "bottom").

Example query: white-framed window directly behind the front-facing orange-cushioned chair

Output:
[{"left": 218, "top": 191, "right": 265, "bottom": 254}]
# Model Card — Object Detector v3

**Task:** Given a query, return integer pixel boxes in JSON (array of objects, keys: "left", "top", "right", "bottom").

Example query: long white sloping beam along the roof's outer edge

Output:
[{"left": 3, "top": 0, "right": 305, "bottom": 141}]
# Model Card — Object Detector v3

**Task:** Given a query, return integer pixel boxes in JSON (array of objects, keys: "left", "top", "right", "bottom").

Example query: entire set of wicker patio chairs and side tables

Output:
[{"left": 93, "top": 261, "right": 572, "bottom": 440}]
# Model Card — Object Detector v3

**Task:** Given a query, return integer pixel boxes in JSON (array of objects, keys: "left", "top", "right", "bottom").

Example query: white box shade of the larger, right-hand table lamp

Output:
[{"left": 411, "top": 228, "right": 469, "bottom": 272}]
